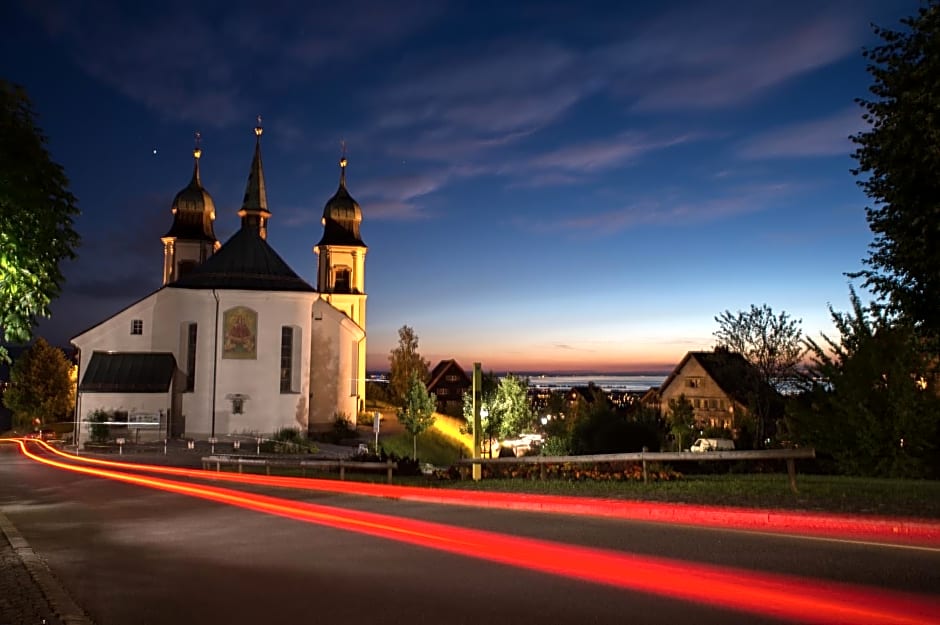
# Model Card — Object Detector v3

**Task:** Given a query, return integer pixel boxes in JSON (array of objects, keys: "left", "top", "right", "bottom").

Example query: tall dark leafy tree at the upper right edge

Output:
[{"left": 850, "top": 0, "right": 940, "bottom": 354}]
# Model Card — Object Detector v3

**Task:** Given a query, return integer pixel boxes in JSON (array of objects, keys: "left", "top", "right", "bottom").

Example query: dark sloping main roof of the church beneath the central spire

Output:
[{"left": 167, "top": 228, "right": 316, "bottom": 291}]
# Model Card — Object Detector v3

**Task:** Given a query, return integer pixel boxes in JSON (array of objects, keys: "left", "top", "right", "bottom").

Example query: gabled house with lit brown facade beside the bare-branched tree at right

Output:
[{"left": 659, "top": 350, "right": 781, "bottom": 432}]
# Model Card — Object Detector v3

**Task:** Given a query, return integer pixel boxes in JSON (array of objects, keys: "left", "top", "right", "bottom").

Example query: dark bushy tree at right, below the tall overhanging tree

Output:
[{"left": 788, "top": 290, "right": 940, "bottom": 477}]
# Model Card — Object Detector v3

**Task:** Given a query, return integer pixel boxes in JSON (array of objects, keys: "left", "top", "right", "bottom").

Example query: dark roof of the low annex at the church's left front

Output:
[{"left": 78, "top": 352, "right": 176, "bottom": 393}]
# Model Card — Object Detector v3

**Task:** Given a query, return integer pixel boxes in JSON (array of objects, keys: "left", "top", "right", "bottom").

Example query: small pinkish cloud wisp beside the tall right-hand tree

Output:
[{"left": 738, "top": 107, "right": 865, "bottom": 159}]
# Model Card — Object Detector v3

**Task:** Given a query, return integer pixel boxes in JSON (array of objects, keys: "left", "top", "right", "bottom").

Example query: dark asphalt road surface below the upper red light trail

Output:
[{"left": 0, "top": 445, "right": 940, "bottom": 625}]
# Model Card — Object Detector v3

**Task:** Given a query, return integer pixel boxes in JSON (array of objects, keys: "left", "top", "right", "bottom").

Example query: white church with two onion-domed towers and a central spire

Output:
[{"left": 72, "top": 119, "right": 367, "bottom": 445}]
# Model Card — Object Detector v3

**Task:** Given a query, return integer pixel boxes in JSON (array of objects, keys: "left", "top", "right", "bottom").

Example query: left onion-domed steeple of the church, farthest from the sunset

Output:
[{"left": 160, "top": 132, "right": 219, "bottom": 284}]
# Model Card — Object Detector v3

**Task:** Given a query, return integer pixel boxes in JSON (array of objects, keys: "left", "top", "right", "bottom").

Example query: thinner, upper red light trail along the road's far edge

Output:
[{"left": 25, "top": 440, "right": 940, "bottom": 548}]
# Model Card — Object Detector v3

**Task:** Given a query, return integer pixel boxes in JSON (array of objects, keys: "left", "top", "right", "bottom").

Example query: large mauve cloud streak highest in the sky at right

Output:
[{"left": 598, "top": 2, "right": 866, "bottom": 112}]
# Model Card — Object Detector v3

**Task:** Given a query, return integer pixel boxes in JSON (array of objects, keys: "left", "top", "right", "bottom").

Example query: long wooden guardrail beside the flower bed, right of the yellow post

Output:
[{"left": 457, "top": 448, "right": 816, "bottom": 493}]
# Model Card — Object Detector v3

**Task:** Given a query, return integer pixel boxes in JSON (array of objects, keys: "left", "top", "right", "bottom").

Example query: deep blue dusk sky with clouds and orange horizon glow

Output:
[{"left": 0, "top": 0, "right": 919, "bottom": 372}]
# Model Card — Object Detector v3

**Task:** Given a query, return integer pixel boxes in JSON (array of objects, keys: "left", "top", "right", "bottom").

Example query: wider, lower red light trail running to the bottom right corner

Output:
[{"left": 5, "top": 440, "right": 940, "bottom": 625}]
